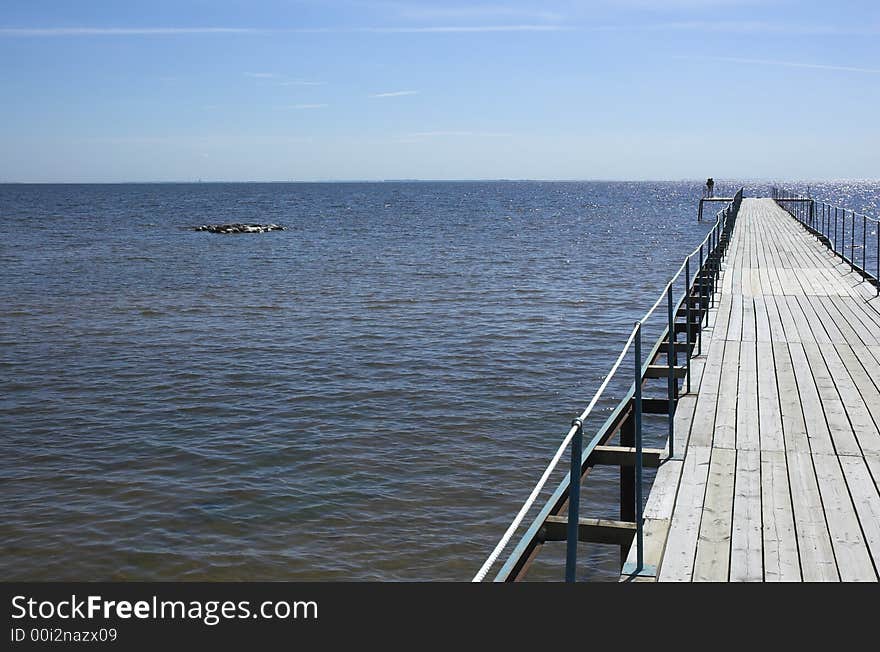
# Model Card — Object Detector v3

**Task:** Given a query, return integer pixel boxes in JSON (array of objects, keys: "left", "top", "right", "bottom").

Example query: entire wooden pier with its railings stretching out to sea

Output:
[{"left": 474, "top": 188, "right": 880, "bottom": 582}]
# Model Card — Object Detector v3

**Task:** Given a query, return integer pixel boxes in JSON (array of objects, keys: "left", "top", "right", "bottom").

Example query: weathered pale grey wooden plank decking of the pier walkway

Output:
[{"left": 622, "top": 199, "right": 880, "bottom": 581}]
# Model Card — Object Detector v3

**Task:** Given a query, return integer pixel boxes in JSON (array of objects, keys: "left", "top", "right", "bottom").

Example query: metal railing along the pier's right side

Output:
[{"left": 773, "top": 187, "right": 880, "bottom": 296}]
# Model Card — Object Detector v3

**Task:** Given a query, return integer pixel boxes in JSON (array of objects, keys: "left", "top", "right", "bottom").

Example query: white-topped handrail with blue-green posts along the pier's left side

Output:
[{"left": 471, "top": 188, "right": 743, "bottom": 582}]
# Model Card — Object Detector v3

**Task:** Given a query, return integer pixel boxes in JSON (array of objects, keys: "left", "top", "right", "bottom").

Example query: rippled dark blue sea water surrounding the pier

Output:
[{"left": 0, "top": 182, "right": 880, "bottom": 580}]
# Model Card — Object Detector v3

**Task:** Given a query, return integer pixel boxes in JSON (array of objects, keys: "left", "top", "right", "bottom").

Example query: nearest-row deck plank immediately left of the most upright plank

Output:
[{"left": 694, "top": 448, "right": 737, "bottom": 582}]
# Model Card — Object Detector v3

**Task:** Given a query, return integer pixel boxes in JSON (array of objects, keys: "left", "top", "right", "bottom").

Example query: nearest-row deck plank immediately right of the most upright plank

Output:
[{"left": 761, "top": 451, "right": 801, "bottom": 582}]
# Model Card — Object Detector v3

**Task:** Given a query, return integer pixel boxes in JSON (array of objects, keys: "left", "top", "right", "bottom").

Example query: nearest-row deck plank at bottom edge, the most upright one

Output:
[{"left": 730, "top": 450, "right": 764, "bottom": 582}]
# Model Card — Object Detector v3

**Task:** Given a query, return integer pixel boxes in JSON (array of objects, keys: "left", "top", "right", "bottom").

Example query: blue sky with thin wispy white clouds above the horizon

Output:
[{"left": 0, "top": 0, "right": 880, "bottom": 182}]
